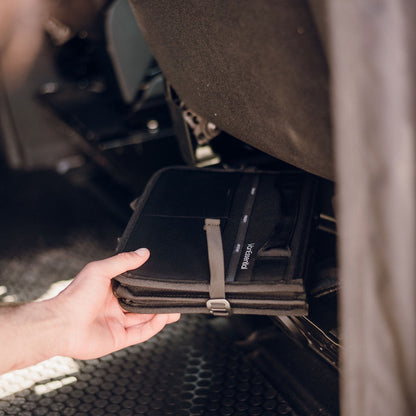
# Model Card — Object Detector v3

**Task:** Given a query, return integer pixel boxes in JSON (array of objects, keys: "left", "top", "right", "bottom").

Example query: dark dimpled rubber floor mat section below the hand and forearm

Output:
[{"left": 0, "top": 315, "right": 294, "bottom": 416}]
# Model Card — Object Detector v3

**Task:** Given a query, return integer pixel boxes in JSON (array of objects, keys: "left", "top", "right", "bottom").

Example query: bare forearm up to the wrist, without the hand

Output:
[{"left": 0, "top": 301, "right": 63, "bottom": 374}]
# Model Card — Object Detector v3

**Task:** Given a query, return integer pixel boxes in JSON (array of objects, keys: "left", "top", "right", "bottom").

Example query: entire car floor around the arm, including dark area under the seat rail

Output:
[{"left": 0, "top": 141, "right": 338, "bottom": 416}]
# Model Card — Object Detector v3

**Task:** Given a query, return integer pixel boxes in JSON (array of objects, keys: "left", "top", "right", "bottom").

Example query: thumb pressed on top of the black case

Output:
[{"left": 84, "top": 248, "right": 150, "bottom": 279}]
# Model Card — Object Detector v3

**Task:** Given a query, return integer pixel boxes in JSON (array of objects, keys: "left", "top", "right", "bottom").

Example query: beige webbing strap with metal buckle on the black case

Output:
[{"left": 204, "top": 218, "right": 231, "bottom": 316}]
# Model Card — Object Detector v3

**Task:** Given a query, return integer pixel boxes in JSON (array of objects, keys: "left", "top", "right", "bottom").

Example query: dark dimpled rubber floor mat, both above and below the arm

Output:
[{"left": 0, "top": 172, "right": 294, "bottom": 416}]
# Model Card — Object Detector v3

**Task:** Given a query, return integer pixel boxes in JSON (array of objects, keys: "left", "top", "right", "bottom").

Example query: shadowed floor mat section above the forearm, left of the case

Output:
[{"left": 0, "top": 172, "right": 122, "bottom": 302}]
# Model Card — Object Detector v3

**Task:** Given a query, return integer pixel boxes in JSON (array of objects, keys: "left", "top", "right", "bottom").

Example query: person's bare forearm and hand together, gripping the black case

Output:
[{"left": 0, "top": 249, "right": 179, "bottom": 374}]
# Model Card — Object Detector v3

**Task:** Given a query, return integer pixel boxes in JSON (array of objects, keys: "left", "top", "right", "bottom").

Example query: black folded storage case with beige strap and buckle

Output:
[{"left": 113, "top": 167, "right": 315, "bottom": 315}]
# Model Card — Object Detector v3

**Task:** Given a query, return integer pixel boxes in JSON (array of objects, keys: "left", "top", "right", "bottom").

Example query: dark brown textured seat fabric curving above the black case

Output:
[{"left": 131, "top": 0, "right": 334, "bottom": 179}]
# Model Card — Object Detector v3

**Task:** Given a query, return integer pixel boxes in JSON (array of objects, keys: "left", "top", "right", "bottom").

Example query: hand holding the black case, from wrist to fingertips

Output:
[{"left": 49, "top": 249, "right": 180, "bottom": 359}]
